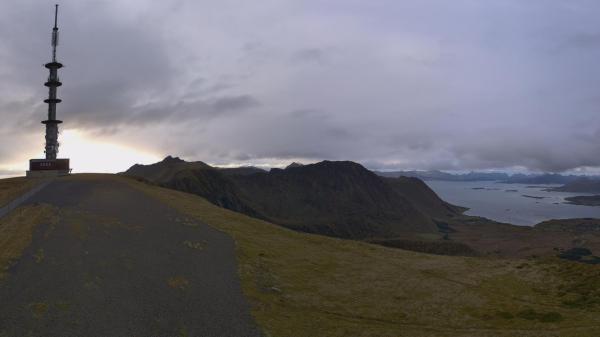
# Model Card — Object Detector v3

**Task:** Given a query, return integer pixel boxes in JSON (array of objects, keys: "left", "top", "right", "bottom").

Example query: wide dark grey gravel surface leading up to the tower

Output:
[{"left": 0, "top": 178, "right": 260, "bottom": 337}]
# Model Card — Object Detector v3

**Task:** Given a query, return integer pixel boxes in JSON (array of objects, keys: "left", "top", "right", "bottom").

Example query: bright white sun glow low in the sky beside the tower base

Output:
[{"left": 59, "top": 130, "right": 160, "bottom": 173}]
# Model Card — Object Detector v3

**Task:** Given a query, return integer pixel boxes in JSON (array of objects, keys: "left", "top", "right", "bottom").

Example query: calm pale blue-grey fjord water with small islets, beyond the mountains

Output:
[{"left": 426, "top": 181, "right": 600, "bottom": 226}]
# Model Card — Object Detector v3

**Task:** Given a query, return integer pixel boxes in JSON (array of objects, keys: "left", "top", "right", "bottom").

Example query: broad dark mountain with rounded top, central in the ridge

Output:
[{"left": 232, "top": 161, "right": 437, "bottom": 239}]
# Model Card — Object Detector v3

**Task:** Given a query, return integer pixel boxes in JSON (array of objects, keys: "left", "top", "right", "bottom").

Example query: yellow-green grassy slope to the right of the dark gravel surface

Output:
[{"left": 115, "top": 177, "right": 600, "bottom": 337}]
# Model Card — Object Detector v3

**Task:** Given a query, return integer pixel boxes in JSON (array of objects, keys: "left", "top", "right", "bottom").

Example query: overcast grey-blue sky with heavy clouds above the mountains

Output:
[{"left": 0, "top": 0, "right": 600, "bottom": 173}]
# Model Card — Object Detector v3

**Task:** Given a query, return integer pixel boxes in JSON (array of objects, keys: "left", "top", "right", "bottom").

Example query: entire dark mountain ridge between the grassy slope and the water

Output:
[{"left": 124, "top": 156, "right": 465, "bottom": 239}]
